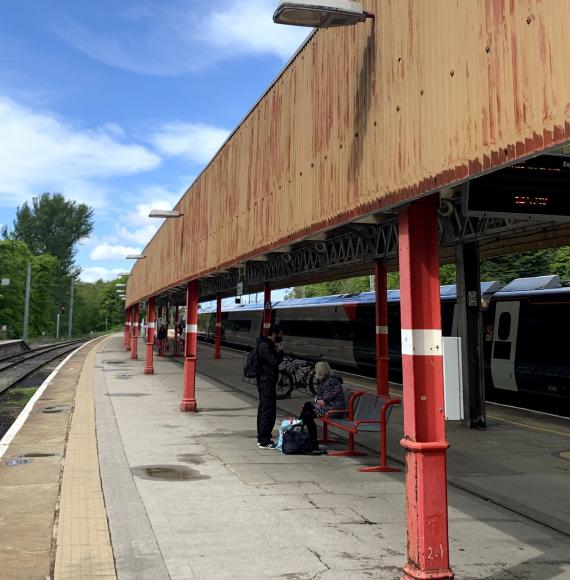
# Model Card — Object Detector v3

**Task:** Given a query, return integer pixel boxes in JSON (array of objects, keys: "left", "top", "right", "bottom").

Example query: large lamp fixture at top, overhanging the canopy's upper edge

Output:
[{"left": 273, "top": 0, "right": 370, "bottom": 28}]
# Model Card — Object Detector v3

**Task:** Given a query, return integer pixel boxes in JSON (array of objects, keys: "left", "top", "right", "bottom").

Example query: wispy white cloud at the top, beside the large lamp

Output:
[{"left": 57, "top": 0, "right": 308, "bottom": 76}]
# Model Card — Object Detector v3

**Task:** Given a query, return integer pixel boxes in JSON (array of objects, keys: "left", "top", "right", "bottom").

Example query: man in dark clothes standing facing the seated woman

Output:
[{"left": 256, "top": 324, "right": 283, "bottom": 449}]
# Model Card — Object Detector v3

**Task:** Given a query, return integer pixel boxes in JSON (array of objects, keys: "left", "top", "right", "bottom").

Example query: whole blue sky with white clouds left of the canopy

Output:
[{"left": 0, "top": 0, "right": 307, "bottom": 288}]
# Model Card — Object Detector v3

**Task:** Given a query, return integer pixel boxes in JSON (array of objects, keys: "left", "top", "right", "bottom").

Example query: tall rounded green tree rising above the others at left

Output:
[{"left": 2, "top": 193, "right": 93, "bottom": 276}]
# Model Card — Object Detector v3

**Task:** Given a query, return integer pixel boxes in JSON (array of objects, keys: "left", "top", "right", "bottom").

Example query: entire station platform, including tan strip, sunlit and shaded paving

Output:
[{"left": 0, "top": 335, "right": 570, "bottom": 580}]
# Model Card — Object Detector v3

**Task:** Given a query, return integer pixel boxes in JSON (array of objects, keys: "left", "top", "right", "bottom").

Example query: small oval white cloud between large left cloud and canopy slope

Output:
[{"left": 151, "top": 123, "right": 230, "bottom": 163}]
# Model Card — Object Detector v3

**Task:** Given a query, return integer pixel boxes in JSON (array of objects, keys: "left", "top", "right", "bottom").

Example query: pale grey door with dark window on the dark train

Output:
[{"left": 491, "top": 301, "right": 520, "bottom": 391}]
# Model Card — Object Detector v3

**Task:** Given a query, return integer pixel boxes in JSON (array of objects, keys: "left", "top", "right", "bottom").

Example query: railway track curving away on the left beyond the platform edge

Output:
[{"left": 0, "top": 340, "right": 85, "bottom": 394}]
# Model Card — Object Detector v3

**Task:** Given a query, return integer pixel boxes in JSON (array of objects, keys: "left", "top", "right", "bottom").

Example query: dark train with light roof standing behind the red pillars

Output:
[{"left": 198, "top": 276, "right": 570, "bottom": 409}]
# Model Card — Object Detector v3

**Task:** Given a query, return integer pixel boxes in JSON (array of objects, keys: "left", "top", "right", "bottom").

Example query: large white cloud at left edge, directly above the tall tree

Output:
[{"left": 0, "top": 96, "right": 161, "bottom": 207}]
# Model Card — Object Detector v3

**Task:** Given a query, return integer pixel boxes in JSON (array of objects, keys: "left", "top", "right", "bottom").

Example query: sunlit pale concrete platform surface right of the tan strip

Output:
[{"left": 94, "top": 336, "right": 570, "bottom": 580}]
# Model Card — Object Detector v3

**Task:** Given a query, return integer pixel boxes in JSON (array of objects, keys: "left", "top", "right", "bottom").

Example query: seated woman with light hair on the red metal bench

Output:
[{"left": 299, "top": 361, "right": 345, "bottom": 450}]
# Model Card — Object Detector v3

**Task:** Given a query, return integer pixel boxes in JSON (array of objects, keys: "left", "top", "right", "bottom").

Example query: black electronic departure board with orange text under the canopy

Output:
[{"left": 462, "top": 155, "right": 570, "bottom": 221}]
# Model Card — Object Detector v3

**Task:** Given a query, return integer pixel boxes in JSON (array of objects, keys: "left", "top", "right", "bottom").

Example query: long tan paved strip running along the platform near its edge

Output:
[{"left": 55, "top": 340, "right": 117, "bottom": 580}]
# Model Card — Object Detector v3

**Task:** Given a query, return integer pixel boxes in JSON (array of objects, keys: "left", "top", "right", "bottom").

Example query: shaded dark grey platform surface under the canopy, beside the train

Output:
[{"left": 194, "top": 344, "right": 570, "bottom": 536}]
